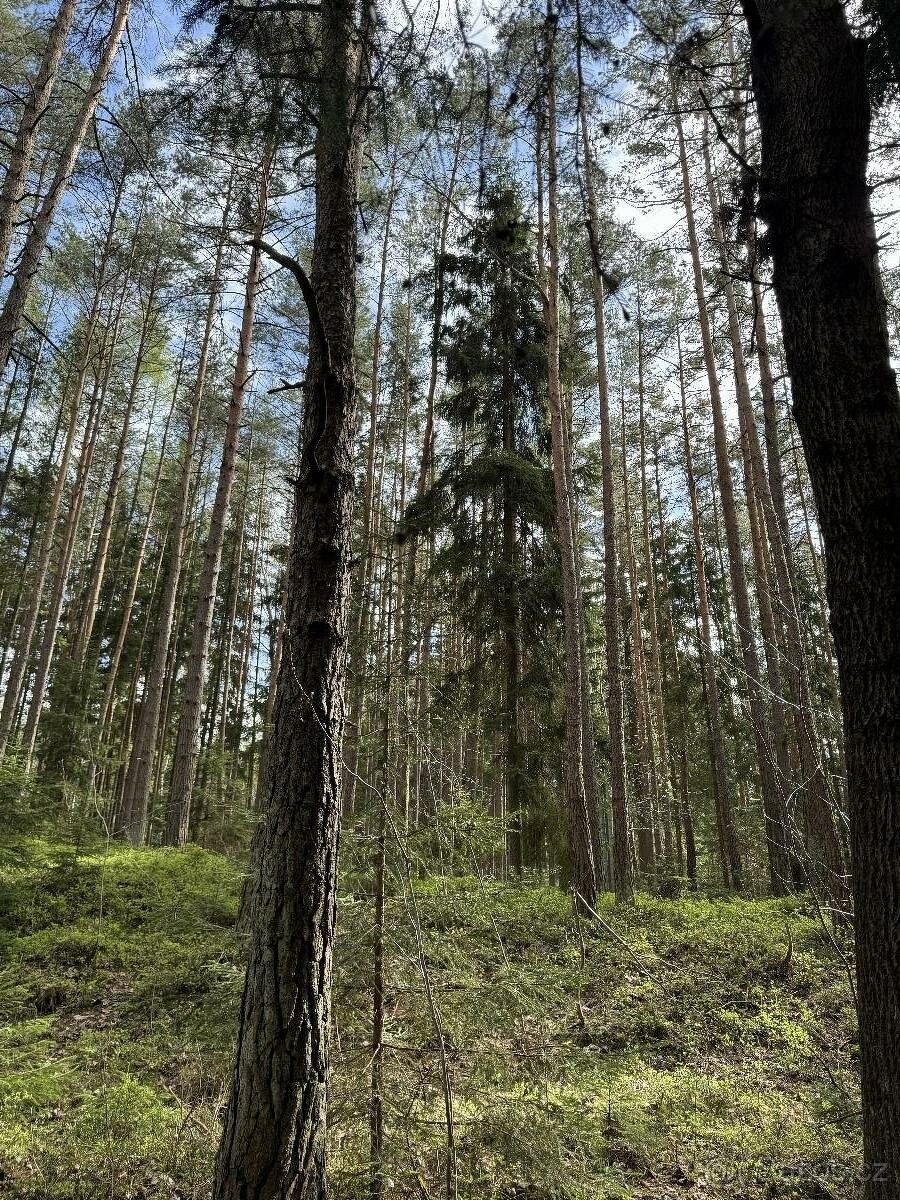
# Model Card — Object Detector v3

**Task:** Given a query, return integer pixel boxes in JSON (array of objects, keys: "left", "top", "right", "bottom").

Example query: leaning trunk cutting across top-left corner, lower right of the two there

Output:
[{"left": 0, "top": 0, "right": 131, "bottom": 368}]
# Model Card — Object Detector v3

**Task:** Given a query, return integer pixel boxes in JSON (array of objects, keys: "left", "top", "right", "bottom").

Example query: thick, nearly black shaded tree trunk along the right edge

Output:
[{"left": 744, "top": 0, "right": 900, "bottom": 1180}]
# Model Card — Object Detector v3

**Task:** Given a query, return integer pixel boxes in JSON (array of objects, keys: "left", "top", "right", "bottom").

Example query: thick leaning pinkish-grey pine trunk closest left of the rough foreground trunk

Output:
[{"left": 164, "top": 145, "right": 275, "bottom": 846}]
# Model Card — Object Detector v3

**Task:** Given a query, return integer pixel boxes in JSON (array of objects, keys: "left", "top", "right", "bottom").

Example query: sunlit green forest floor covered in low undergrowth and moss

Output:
[{"left": 0, "top": 839, "right": 859, "bottom": 1200}]
